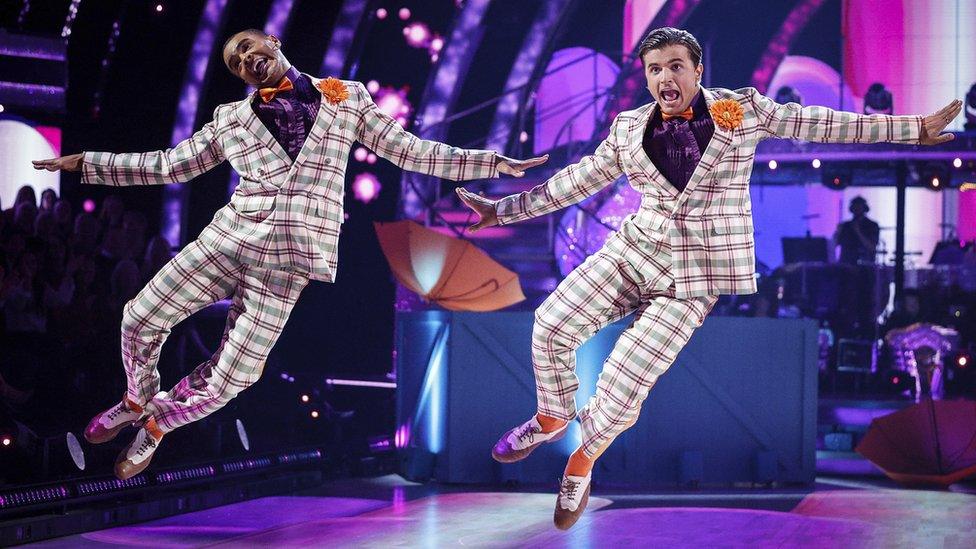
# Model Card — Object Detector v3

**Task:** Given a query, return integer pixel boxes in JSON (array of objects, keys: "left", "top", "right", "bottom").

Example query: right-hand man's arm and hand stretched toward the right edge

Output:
[{"left": 743, "top": 88, "right": 962, "bottom": 145}]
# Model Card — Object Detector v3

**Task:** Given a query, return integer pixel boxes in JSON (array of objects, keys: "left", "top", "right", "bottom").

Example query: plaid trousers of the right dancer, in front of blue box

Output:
[{"left": 532, "top": 220, "right": 718, "bottom": 456}]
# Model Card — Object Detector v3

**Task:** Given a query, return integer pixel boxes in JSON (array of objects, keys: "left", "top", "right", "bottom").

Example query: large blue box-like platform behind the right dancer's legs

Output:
[{"left": 396, "top": 311, "right": 817, "bottom": 488}]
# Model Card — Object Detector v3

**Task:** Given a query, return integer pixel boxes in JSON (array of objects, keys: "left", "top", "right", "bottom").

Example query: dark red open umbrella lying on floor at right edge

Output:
[{"left": 856, "top": 399, "right": 976, "bottom": 487}]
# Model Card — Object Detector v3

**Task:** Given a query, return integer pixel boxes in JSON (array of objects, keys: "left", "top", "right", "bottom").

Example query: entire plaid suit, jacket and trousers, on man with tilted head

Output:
[{"left": 82, "top": 75, "right": 498, "bottom": 431}]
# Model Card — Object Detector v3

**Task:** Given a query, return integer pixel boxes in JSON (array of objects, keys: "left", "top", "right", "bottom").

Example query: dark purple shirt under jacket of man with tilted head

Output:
[{"left": 251, "top": 67, "right": 322, "bottom": 160}]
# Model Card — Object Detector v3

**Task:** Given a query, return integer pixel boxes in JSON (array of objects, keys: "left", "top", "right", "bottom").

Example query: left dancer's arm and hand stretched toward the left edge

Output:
[{"left": 34, "top": 106, "right": 224, "bottom": 186}]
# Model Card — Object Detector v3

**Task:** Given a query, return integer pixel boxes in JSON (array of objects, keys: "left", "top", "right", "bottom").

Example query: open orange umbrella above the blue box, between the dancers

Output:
[{"left": 373, "top": 221, "right": 525, "bottom": 311}]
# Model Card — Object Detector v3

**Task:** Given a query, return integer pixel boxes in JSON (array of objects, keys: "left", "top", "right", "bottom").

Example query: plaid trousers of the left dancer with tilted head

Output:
[{"left": 122, "top": 240, "right": 308, "bottom": 431}]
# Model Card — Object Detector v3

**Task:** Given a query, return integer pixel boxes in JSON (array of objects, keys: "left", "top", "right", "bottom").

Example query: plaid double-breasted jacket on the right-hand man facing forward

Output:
[{"left": 495, "top": 88, "right": 922, "bottom": 298}]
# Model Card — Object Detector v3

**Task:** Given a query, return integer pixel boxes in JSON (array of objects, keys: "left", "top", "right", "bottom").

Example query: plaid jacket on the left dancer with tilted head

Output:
[{"left": 82, "top": 78, "right": 498, "bottom": 282}]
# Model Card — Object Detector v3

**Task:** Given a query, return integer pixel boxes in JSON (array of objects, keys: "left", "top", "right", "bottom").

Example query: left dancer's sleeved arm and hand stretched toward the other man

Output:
[{"left": 354, "top": 82, "right": 547, "bottom": 181}]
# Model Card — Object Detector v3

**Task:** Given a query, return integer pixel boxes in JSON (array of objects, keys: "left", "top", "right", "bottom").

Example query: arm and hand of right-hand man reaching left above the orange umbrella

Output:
[{"left": 457, "top": 116, "right": 623, "bottom": 232}]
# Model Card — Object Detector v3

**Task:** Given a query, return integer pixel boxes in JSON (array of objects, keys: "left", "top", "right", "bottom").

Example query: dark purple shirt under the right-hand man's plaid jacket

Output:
[{"left": 643, "top": 90, "right": 715, "bottom": 192}]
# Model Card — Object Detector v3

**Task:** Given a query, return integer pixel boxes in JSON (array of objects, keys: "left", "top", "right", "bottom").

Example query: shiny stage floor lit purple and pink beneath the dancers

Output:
[{"left": 24, "top": 476, "right": 976, "bottom": 549}]
